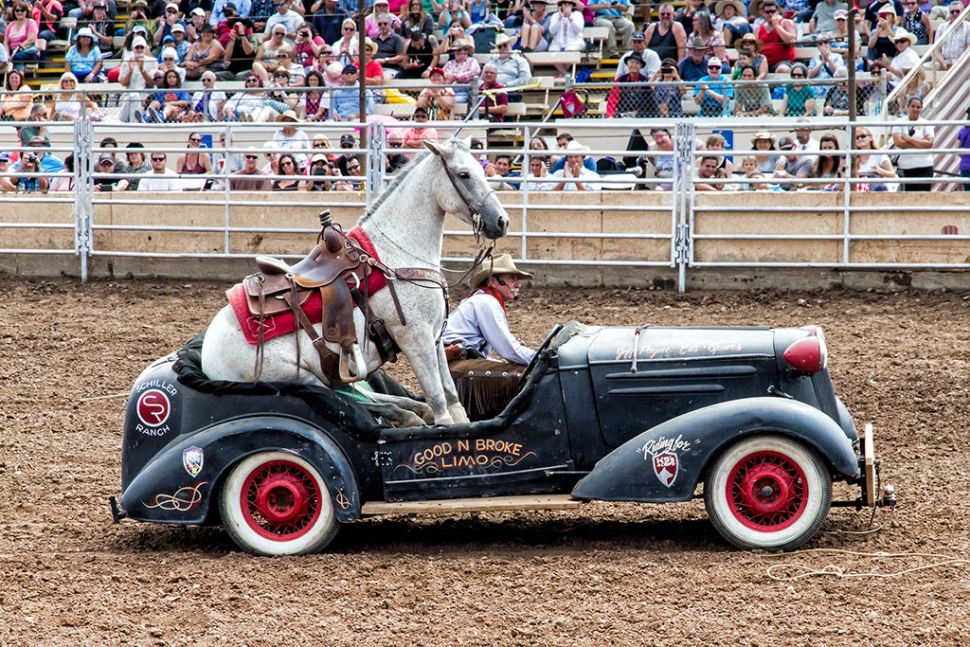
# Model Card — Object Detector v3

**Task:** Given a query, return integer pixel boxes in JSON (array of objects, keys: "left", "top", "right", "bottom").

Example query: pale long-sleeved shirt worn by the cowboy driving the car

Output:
[{"left": 441, "top": 290, "right": 536, "bottom": 364}]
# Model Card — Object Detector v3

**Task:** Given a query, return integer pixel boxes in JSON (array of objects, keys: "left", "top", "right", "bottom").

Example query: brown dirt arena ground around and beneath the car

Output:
[{"left": 0, "top": 277, "right": 970, "bottom": 647}]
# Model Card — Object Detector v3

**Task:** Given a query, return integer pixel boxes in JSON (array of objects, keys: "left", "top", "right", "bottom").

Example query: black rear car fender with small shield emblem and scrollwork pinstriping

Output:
[{"left": 121, "top": 415, "right": 361, "bottom": 524}]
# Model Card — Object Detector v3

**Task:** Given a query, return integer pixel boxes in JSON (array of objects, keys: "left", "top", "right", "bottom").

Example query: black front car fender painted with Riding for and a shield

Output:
[{"left": 572, "top": 398, "right": 859, "bottom": 502}]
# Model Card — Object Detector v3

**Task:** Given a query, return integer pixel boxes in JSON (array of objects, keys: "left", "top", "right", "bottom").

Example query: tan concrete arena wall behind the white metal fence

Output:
[{"left": 0, "top": 191, "right": 970, "bottom": 289}]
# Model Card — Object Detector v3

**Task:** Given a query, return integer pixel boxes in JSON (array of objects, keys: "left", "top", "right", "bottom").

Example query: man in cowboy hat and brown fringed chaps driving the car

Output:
[{"left": 441, "top": 254, "right": 535, "bottom": 420}]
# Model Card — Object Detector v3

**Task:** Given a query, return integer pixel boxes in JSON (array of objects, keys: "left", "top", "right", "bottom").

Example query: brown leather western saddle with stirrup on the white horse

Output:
[{"left": 243, "top": 211, "right": 372, "bottom": 383}]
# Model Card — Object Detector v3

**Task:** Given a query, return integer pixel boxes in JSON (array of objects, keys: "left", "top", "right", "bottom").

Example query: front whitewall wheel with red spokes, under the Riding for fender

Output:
[{"left": 704, "top": 436, "right": 832, "bottom": 550}]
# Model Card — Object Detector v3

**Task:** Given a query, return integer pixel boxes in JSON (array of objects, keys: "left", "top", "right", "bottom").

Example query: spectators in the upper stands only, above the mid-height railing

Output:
[{"left": 0, "top": 0, "right": 970, "bottom": 122}]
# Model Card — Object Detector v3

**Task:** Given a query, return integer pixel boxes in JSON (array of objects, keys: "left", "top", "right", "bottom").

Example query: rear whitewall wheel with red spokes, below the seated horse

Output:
[{"left": 219, "top": 452, "right": 340, "bottom": 555}]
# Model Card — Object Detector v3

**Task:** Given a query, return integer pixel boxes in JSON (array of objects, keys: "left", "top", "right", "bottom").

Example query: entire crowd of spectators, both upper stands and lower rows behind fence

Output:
[{"left": 0, "top": 0, "right": 970, "bottom": 191}]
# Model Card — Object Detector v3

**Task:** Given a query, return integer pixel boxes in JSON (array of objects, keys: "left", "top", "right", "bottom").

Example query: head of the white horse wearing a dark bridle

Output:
[{"left": 424, "top": 138, "right": 509, "bottom": 240}]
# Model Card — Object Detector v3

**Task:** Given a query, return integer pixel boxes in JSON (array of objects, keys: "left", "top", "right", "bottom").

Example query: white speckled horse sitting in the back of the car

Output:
[{"left": 202, "top": 139, "right": 509, "bottom": 426}]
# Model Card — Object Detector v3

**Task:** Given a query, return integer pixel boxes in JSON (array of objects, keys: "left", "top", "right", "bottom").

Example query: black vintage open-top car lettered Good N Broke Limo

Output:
[{"left": 111, "top": 324, "right": 892, "bottom": 555}]
